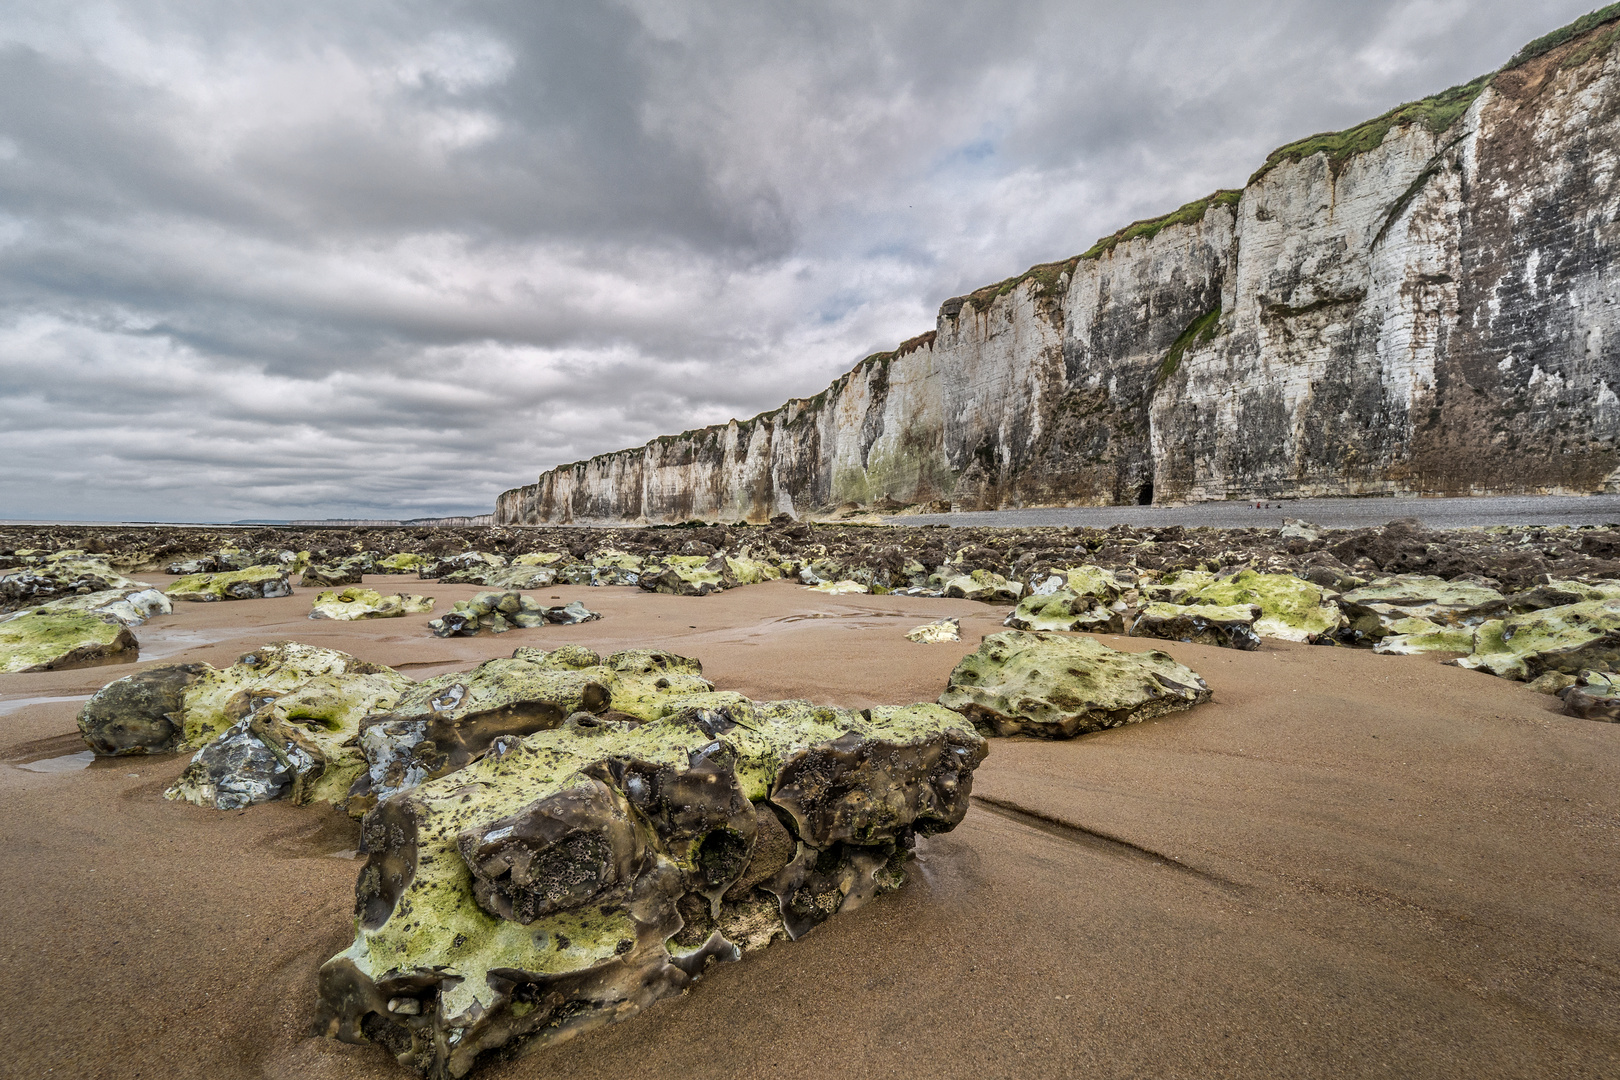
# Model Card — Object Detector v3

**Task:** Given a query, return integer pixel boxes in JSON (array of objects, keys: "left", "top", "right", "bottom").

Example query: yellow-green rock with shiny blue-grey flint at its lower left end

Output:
[{"left": 164, "top": 669, "right": 411, "bottom": 810}]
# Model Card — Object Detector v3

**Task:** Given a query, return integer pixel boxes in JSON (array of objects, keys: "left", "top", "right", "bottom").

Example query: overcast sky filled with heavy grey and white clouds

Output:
[{"left": 0, "top": 0, "right": 1594, "bottom": 521}]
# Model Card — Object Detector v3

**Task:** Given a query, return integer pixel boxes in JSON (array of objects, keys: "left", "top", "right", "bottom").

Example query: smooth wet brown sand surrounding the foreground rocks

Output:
[{"left": 0, "top": 575, "right": 1620, "bottom": 1080}]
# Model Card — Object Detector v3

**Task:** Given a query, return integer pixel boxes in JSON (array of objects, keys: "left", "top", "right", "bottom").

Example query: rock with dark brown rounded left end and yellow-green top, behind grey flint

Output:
[{"left": 77, "top": 647, "right": 395, "bottom": 753}]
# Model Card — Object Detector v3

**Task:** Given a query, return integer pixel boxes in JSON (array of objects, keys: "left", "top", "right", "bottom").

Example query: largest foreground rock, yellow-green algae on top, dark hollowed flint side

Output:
[{"left": 309, "top": 703, "right": 987, "bottom": 1077}]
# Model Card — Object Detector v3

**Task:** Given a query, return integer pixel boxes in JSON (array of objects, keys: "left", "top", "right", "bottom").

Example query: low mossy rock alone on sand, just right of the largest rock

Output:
[{"left": 940, "top": 630, "right": 1210, "bottom": 738}]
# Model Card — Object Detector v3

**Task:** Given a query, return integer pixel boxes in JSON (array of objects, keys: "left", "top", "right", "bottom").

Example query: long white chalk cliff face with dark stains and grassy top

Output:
[{"left": 496, "top": 10, "right": 1620, "bottom": 525}]
